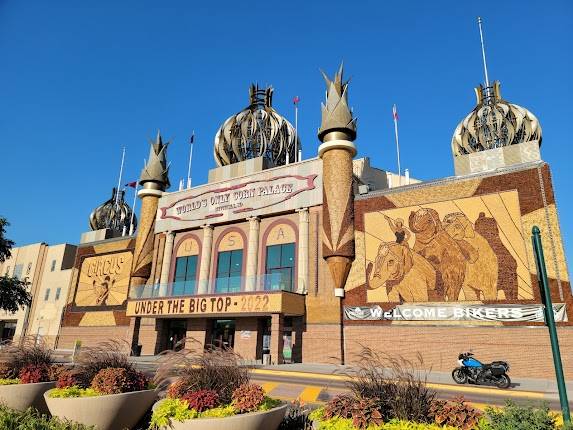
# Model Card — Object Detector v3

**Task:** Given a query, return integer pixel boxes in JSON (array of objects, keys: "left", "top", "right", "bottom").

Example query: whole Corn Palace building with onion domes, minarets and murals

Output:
[{"left": 58, "top": 69, "right": 573, "bottom": 377}]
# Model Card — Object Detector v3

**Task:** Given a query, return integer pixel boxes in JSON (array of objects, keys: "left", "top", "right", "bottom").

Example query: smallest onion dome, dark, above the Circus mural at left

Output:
[{"left": 90, "top": 187, "right": 137, "bottom": 233}]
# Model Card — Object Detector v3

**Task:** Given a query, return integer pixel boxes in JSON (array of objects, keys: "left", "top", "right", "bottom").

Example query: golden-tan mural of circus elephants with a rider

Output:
[{"left": 364, "top": 191, "right": 533, "bottom": 303}]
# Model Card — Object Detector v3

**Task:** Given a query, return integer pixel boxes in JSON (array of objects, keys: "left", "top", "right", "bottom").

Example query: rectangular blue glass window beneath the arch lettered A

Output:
[{"left": 265, "top": 243, "right": 295, "bottom": 291}]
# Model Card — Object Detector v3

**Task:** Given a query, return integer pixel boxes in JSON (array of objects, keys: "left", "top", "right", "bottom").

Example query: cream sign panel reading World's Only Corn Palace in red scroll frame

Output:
[{"left": 155, "top": 160, "right": 322, "bottom": 233}]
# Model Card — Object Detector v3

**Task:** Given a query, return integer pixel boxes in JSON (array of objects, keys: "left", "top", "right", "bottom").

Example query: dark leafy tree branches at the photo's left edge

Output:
[{"left": 0, "top": 217, "right": 32, "bottom": 313}]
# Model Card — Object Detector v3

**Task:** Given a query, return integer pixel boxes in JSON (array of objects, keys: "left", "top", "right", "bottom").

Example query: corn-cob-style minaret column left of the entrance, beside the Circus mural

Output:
[{"left": 131, "top": 132, "right": 170, "bottom": 287}]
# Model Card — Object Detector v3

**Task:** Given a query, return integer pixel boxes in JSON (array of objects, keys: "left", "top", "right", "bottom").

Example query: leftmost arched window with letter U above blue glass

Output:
[{"left": 172, "top": 237, "right": 199, "bottom": 296}]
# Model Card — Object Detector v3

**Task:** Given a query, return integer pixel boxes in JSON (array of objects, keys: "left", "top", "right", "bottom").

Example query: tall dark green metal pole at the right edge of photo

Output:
[{"left": 531, "top": 225, "right": 571, "bottom": 423}]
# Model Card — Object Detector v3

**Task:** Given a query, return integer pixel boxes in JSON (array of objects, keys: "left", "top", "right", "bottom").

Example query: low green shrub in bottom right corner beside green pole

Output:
[{"left": 479, "top": 400, "right": 556, "bottom": 430}]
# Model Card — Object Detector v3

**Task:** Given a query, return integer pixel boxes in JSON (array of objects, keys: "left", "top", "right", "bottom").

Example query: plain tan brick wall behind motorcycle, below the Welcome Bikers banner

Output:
[{"left": 344, "top": 324, "right": 573, "bottom": 382}]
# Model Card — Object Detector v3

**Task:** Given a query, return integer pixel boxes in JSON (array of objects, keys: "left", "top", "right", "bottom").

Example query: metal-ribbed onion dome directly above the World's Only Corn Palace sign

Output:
[{"left": 214, "top": 85, "right": 299, "bottom": 166}]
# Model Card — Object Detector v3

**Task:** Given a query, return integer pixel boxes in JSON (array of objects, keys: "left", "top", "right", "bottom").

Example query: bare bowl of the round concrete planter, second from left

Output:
[{"left": 44, "top": 390, "right": 157, "bottom": 430}]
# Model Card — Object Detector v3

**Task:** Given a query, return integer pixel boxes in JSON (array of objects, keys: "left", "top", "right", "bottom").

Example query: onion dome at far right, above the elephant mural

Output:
[{"left": 452, "top": 81, "right": 541, "bottom": 156}]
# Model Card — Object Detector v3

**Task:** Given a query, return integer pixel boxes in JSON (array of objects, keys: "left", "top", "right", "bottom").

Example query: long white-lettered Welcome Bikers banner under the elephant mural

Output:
[{"left": 344, "top": 303, "right": 568, "bottom": 322}]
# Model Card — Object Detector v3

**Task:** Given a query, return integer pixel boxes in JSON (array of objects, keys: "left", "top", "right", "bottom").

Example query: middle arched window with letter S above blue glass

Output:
[{"left": 215, "top": 230, "right": 245, "bottom": 293}]
